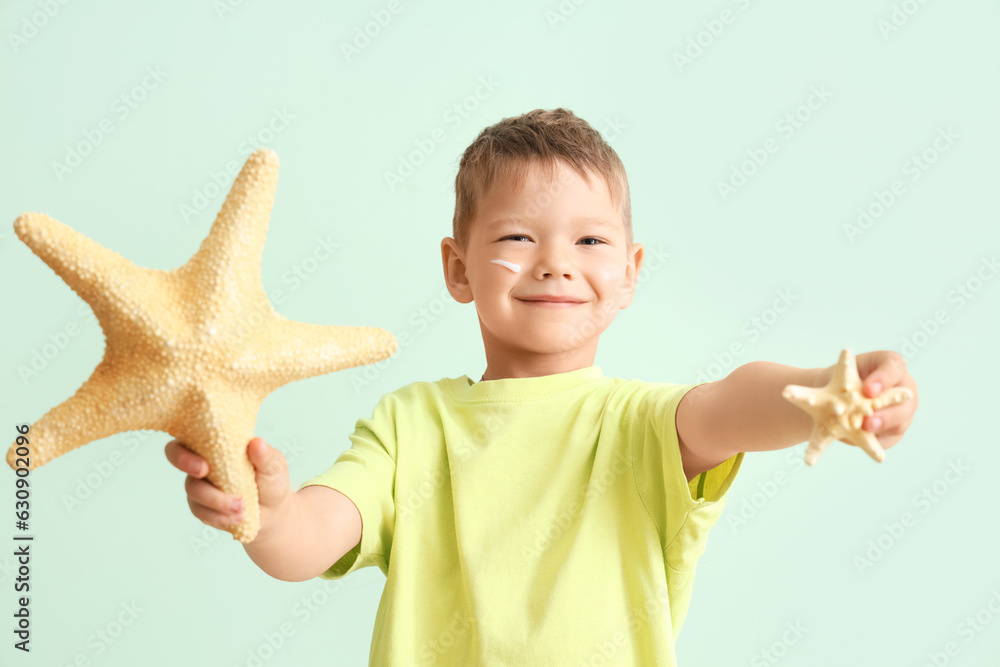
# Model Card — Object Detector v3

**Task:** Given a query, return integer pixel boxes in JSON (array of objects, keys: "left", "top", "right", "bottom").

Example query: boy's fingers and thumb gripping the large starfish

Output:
[{"left": 164, "top": 437, "right": 291, "bottom": 532}]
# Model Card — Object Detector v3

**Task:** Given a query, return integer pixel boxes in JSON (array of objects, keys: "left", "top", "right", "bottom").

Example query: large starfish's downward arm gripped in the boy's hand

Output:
[{"left": 167, "top": 380, "right": 262, "bottom": 544}]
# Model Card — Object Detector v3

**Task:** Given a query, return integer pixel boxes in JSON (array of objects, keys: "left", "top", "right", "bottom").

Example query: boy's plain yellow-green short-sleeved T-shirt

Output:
[{"left": 300, "top": 366, "right": 743, "bottom": 667}]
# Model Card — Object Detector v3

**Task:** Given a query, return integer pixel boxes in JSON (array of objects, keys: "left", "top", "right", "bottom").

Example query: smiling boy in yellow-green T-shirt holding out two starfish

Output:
[{"left": 166, "top": 108, "right": 916, "bottom": 666}]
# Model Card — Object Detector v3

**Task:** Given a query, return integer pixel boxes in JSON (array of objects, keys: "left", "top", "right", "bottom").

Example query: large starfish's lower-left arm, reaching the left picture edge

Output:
[{"left": 7, "top": 357, "right": 182, "bottom": 470}]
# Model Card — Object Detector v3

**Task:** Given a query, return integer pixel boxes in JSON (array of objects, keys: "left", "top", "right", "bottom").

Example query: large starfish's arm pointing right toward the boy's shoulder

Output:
[{"left": 234, "top": 314, "right": 397, "bottom": 395}]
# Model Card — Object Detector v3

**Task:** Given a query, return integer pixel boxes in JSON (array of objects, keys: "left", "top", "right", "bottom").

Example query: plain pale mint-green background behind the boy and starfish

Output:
[{"left": 0, "top": 0, "right": 1000, "bottom": 667}]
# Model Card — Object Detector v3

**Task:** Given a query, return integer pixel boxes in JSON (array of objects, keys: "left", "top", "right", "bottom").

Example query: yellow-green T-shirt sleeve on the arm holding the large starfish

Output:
[{"left": 299, "top": 394, "right": 396, "bottom": 579}]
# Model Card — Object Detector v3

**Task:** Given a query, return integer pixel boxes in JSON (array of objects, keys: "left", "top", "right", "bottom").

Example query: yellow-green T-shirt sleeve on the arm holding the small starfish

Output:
[{"left": 630, "top": 382, "right": 743, "bottom": 572}]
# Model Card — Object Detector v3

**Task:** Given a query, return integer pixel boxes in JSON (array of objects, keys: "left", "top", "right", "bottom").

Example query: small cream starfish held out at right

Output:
[{"left": 781, "top": 348, "right": 913, "bottom": 465}]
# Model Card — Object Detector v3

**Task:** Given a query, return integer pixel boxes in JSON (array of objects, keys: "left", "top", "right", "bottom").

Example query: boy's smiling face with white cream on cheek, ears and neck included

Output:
[{"left": 441, "top": 160, "right": 643, "bottom": 379}]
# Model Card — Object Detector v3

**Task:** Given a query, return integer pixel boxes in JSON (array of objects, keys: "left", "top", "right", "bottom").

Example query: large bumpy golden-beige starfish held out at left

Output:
[{"left": 7, "top": 149, "right": 396, "bottom": 543}]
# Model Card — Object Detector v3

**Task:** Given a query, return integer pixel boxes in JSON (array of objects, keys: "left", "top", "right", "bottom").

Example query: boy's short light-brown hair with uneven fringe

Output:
[{"left": 452, "top": 107, "right": 632, "bottom": 250}]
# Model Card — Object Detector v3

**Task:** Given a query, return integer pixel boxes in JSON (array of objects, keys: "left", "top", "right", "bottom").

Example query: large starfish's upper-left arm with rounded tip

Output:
[{"left": 14, "top": 213, "right": 183, "bottom": 338}]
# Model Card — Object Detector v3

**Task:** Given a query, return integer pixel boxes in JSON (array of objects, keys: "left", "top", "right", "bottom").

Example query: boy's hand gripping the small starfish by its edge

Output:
[{"left": 854, "top": 350, "right": 919, "bottom": 449}]
